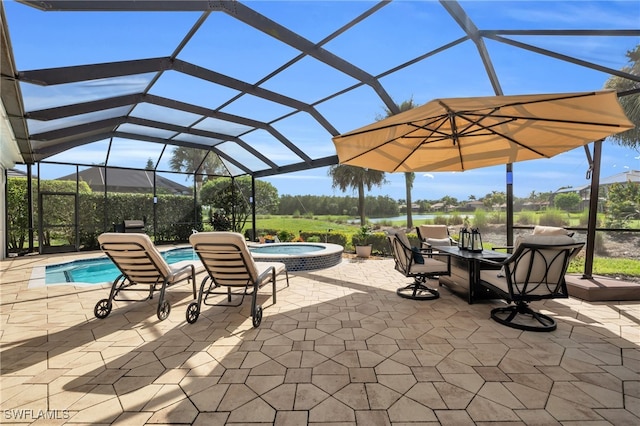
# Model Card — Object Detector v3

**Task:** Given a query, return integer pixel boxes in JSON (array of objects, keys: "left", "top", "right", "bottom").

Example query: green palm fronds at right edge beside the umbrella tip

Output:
[{"left": 605, "top": 44, "right": 640, "bottom": 148}]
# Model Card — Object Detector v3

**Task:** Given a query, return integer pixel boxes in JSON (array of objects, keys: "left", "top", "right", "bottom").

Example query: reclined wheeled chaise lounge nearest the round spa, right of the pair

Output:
[{"left": 187, "top": 232, "right": 289, "bottom": 327}]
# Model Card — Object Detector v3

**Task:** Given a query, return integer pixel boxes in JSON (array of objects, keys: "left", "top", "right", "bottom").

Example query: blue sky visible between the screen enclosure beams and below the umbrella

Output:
[{"left": 4, "top": 0, "right": 640, "bottom": 200}]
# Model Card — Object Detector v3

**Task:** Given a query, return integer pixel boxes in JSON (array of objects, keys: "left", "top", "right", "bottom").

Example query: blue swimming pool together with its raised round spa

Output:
[{"left": 44, "top": 243, "right": 343, "bottom": 285}]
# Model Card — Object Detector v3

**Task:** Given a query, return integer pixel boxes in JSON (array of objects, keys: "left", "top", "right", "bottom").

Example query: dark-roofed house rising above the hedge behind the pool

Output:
[{"left": 56, "top": 167, "right": 193, "bottom": 195}]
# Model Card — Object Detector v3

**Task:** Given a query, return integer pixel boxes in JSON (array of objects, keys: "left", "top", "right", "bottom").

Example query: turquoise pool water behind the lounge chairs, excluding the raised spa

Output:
[{"left": 45, "top": 247, "right": 198, "bottom": 284}]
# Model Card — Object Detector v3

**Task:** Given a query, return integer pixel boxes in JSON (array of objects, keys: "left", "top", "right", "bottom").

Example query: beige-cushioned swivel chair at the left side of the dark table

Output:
[{"left": 387, "top": 231, "right": 451, "bottom": 300}]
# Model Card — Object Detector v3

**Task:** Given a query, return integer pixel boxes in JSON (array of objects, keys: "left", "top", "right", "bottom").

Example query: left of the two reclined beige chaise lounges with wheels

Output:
[{"left": 93, "top": 232, "right": 196, "bottom": 321}]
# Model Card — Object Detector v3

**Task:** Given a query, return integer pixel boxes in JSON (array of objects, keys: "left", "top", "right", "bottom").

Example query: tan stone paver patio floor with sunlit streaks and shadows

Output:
[{"left": 0, "top": 253, "right": 640, "bottom": 426}]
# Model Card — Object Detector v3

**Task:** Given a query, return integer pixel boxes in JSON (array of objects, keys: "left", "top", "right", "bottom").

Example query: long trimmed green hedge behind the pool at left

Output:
[{"left": 7, "top": 178, "right": 202, "bottom": 252}]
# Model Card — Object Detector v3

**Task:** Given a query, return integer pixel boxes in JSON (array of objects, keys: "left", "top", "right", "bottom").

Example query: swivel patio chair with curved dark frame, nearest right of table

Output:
[{"left": 479, "top": 235, "right": 584, "bottom": 331}]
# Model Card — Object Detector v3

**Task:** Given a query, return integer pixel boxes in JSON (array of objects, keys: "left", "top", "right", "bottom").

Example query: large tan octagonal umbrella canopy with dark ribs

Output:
[{"left": 333, "top": 90, "right": 633, "bottom": 172}]
